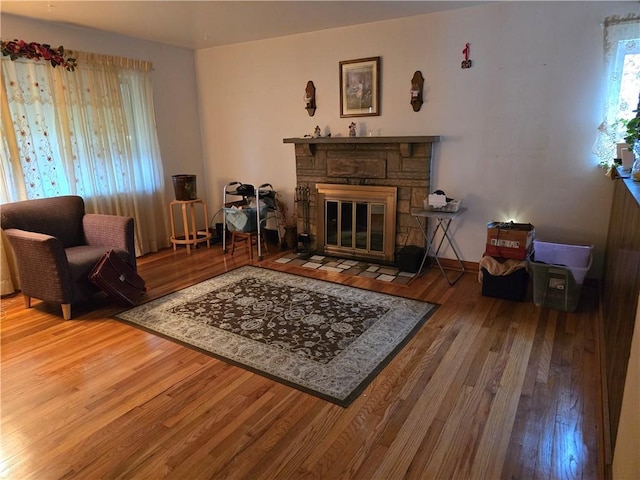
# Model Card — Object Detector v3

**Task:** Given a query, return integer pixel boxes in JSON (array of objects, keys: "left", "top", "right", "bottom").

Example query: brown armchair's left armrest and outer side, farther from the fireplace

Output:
[{"left": 4, "top": 228, "right": 73, "bottom": 303}]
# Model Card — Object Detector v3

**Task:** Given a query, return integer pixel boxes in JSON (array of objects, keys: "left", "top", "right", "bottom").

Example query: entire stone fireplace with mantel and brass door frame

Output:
[{"left": 284, "top": 136, "right": 440, "bottom": 263}]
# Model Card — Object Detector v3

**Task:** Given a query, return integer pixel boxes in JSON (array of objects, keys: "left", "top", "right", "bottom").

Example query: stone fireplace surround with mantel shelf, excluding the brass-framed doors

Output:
[{"left": 284, "top": 136, "right": 440, "bottom": 260}]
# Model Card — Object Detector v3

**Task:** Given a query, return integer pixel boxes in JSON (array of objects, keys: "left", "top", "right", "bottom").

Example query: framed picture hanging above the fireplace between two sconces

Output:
[{"left": 340, "top": 57, "right": 380, "bottom": 118}]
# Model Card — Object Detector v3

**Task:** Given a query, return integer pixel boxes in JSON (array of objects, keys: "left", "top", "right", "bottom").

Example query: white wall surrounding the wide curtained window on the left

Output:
[{"left": 0, "top": 14, "right": 206, "bottom": 216}]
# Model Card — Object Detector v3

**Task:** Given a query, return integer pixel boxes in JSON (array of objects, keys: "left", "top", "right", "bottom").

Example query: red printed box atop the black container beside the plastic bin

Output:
[{"left": 485, "top": 222, "right": 536, "bottom": 260}]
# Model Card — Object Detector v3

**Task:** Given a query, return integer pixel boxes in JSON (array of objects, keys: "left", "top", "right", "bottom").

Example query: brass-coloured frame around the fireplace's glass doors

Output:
[{"left": 316, "top": 183, "right": 398, "bottom": 263}]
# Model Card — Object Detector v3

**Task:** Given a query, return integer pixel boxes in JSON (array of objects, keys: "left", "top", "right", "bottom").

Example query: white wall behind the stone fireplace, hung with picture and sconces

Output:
[{"left": 195, "top": 2, "right": 638, "bottom": 276}]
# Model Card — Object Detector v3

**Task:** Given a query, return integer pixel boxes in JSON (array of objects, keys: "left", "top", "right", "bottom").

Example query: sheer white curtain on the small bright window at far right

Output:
[{"left": 593, "top": 15, "right": 640, "bottom": 164}]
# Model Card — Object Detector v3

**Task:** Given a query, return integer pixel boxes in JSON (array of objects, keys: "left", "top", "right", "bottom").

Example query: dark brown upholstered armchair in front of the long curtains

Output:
[{"left": 0, "top": 195, "right": 136, "bottom": 320}]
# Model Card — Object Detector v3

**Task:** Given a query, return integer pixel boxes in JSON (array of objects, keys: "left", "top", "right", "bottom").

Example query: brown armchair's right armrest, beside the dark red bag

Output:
[{"left": 82, "top": 213, "right": 136, "bottom": 268}]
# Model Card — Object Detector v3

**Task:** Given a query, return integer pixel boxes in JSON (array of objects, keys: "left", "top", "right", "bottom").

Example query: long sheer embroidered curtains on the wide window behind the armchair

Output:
[{"left": 0, "top": 52, "right": 170, "bottom": 293}]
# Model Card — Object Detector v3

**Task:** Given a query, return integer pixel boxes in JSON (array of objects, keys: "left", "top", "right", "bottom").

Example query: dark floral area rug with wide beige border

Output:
[{"left": 116, "top": 266, "right": 437, "bottom": 407}]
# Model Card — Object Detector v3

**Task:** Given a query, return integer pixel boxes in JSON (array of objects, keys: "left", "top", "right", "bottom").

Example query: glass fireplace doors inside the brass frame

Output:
[{"left": 324, "top": 200, "right": 386, "bottom": 253}]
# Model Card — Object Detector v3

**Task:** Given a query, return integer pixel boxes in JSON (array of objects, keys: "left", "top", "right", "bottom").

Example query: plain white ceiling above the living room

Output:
[{"left": 0, "top": 0, "right": 487, "bottom": 49}]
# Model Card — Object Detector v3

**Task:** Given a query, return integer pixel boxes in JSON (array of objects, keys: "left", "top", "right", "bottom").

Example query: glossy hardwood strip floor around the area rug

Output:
[{"left": 0, "top": 246, "right": 603, "bottom": 480}]
